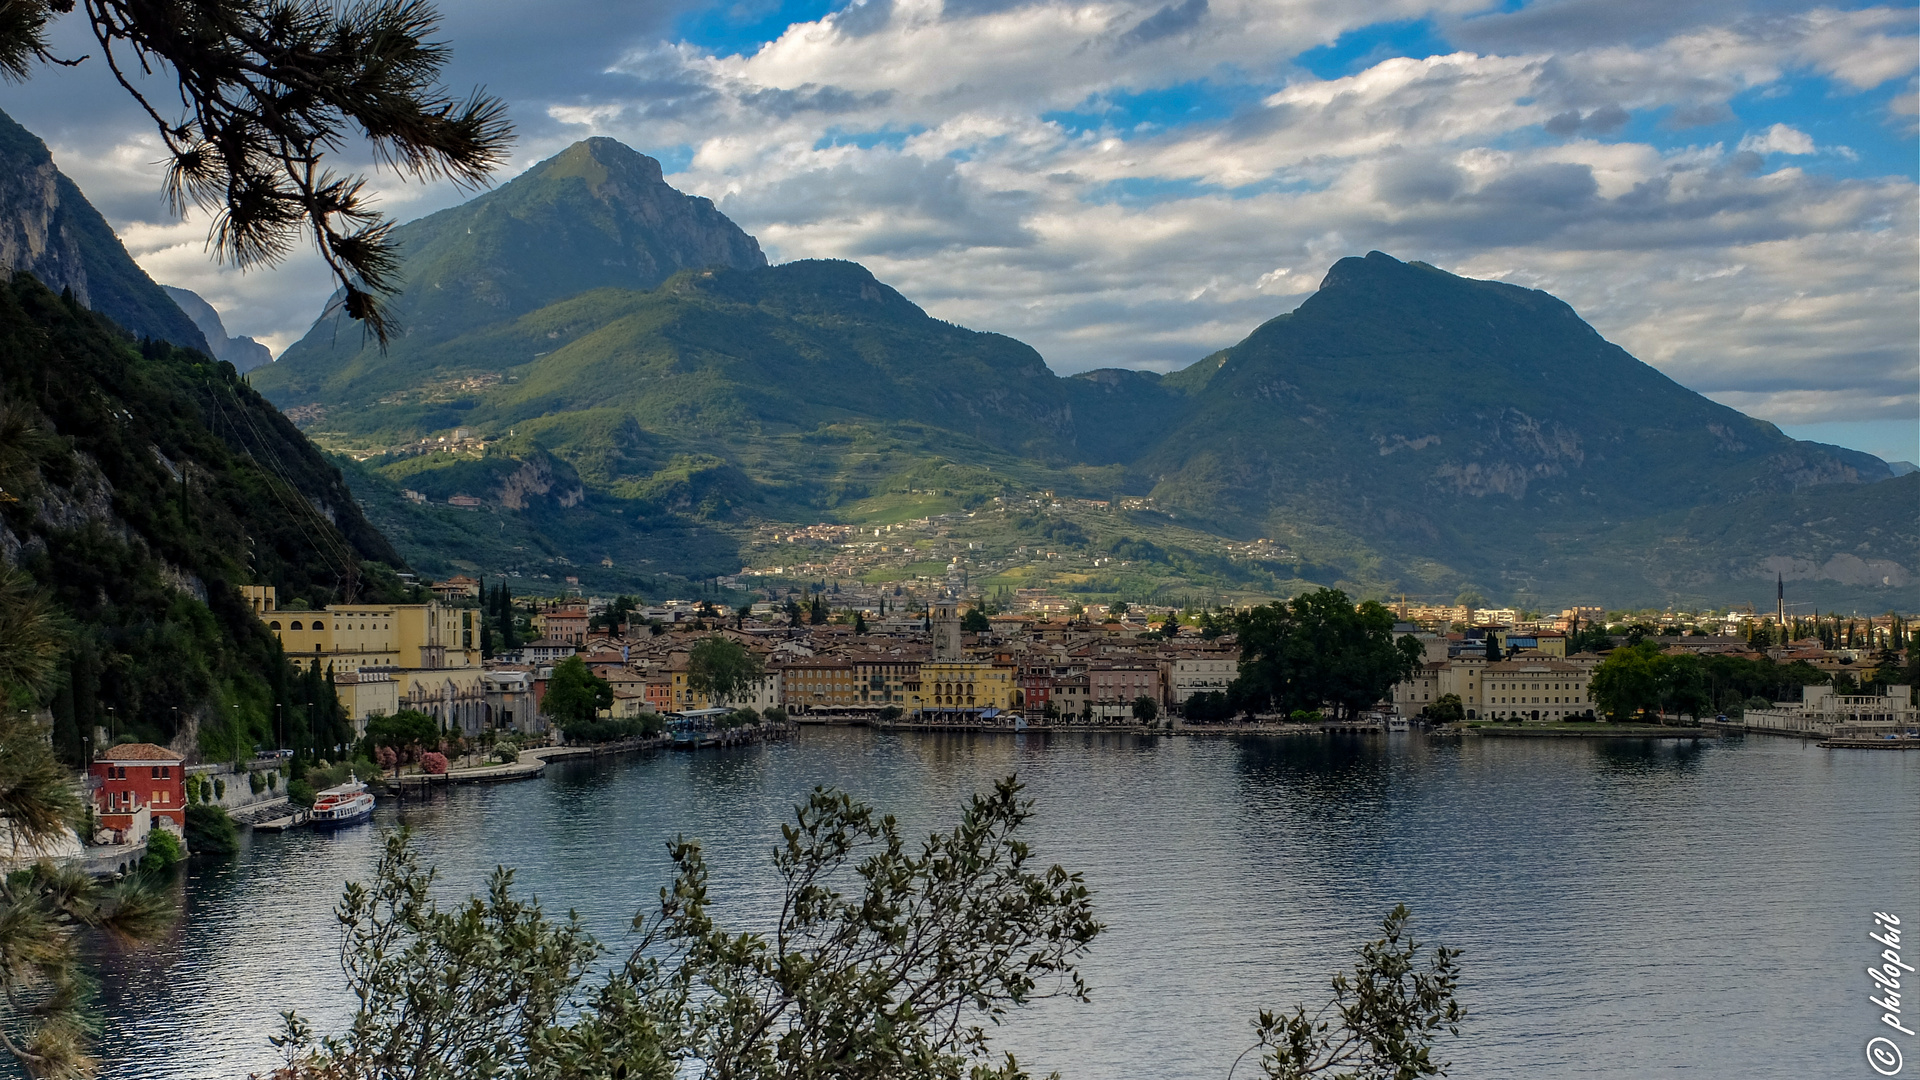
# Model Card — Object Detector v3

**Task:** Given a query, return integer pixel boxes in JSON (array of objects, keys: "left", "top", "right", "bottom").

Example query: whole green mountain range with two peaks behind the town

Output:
[{"left": 253, "top": 140, "right": 1920, "bottom": 607}]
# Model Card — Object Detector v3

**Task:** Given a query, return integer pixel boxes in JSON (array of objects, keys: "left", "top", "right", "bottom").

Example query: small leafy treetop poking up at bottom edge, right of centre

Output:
[{"left": 1229, "top": 905, "right": 1467, "bottom": 1080}]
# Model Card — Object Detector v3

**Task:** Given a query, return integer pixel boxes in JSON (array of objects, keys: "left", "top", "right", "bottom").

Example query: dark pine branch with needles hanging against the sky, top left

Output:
[{"left": 0, "top": 0, "right": 513, "bottom": 344}]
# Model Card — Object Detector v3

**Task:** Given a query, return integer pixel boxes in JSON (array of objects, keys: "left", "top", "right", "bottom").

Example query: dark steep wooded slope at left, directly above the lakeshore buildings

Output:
[{"left": 0, "top": 273, "right": 403, "bottom": 761}]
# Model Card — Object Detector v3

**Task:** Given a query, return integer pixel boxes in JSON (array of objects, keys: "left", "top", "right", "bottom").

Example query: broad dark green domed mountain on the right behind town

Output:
[{"left": 1137, "top": 252, "right": 1910, "bottom": 607}]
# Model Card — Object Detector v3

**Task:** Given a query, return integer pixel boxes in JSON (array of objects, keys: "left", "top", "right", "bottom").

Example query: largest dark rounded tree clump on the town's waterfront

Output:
[{"left": 1229, "top": 588, "right": 1423, "bottom": 719}]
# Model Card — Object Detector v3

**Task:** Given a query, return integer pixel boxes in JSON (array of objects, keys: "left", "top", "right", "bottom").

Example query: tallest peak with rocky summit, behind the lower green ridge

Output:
[{"left": 255, "top": 138, "right": 766, "bottom": 396}]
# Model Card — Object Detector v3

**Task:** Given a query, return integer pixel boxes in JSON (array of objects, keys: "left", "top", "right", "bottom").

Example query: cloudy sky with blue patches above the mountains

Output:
[{"left": 0, "top": 0, "right": 1920, "bottom": 461}]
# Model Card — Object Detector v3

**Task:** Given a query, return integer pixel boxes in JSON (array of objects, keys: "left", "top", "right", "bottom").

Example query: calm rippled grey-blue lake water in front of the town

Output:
[{"left": 78, "top": 728, "right": 1920, "bottom": 1080}]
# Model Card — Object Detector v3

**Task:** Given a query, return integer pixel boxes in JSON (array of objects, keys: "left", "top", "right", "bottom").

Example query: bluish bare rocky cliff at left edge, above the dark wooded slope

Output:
[{"left": 0, "top": 113, "right": 207, "bottom": 350}]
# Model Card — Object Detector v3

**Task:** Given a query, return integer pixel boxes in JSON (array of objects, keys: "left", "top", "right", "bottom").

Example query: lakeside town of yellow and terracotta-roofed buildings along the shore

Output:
[{"left": 48, "top": 549, "right": 1920, "bottom": 867}]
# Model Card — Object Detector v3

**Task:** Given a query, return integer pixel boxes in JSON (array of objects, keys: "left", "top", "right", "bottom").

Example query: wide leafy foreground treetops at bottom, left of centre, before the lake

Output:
[{"left": 276, "top": 778, "right": 1102, "bottom": 1080}]
